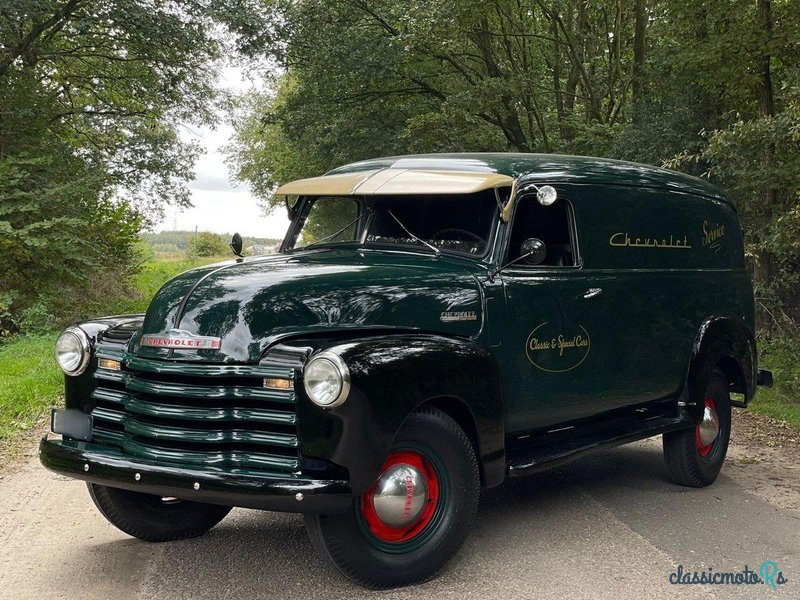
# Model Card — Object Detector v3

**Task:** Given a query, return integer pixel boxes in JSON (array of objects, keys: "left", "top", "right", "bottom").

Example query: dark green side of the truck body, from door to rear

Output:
[{"left": 502, "top": 184, "right": 754, "bottom": 434}]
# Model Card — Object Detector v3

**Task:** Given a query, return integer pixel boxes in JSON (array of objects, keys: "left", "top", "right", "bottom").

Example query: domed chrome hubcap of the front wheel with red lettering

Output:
[{"left": 373, "top": 463, "right": 428, "bottom": 528}]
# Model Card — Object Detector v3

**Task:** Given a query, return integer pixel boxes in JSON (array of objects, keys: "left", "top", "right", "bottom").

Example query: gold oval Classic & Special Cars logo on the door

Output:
[{"left": 525, "top": 322, "right": 592, "bottom": 373}]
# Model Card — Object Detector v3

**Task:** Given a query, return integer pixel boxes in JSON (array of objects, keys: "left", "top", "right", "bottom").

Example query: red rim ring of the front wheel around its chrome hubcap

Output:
[{"left": 361, "top": 450, "right": 439, "bottom": 543}]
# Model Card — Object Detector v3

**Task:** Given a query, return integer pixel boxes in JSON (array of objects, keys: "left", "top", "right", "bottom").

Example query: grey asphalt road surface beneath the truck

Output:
[{"left": 0, "top": 440, "right": 800, "bottom": 600}]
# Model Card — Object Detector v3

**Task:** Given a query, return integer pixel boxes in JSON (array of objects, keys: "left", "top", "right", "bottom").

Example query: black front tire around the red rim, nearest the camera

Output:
[{"left": 305, "top": 409, "right": 480, "bottom": 589}]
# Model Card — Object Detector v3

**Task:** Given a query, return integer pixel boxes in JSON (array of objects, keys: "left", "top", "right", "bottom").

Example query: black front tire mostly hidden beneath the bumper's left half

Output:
[{"left": 86, "top": 483, "right": 232, "bottom": 542}]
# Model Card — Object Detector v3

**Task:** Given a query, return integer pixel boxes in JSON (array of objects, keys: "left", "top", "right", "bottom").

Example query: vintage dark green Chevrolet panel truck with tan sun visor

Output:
[{"left": 40, "top": 154, "right": 771, "bottom": 588}]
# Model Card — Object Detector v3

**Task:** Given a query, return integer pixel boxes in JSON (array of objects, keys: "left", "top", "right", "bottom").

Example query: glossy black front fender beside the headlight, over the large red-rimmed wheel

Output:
[{"left": 298, "top": 334, "right": 505, "bottom": 494}]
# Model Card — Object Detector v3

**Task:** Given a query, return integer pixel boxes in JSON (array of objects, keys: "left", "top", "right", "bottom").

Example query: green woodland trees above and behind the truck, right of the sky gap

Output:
[{"left": 230, "top": 0, "right": 800, "bottom": 332}]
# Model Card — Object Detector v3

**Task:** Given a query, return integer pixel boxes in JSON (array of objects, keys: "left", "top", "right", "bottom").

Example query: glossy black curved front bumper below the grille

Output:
[{"left": 39, "top": 437, "right": 353, "bottom": 513}]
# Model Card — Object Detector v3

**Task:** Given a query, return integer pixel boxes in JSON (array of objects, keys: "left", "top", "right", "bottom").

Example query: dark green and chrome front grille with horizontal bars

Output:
[{"left": 92, "top": 348, "right": 300, "bottom": 473}]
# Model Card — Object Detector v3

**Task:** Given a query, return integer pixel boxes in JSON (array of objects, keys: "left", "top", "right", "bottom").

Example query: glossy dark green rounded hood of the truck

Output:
[{"left": 132, "top": 249, "right": 483, "bottom": 362}]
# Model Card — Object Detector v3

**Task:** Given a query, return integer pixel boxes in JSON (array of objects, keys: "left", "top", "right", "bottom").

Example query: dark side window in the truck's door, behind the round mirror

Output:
[{"left": 508, "top": 196, "right": 578, "bottom": 267}]
